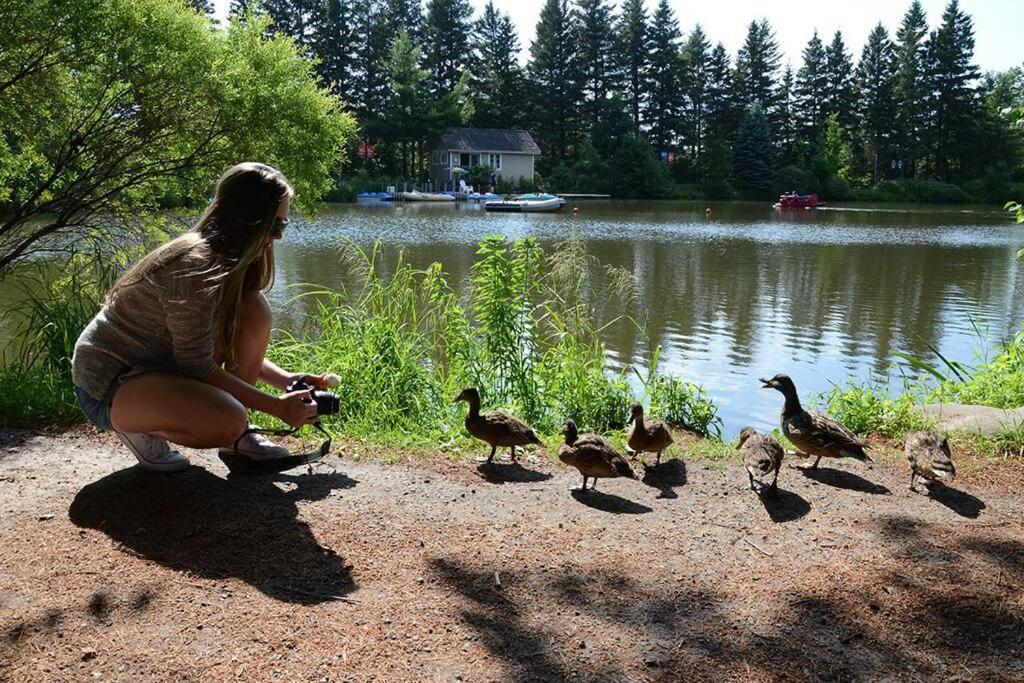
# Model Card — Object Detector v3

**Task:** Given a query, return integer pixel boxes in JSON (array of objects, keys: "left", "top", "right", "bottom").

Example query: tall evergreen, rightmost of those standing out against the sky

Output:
[{"left": 926, "top": 0, "right": 978, "bottom": 180}]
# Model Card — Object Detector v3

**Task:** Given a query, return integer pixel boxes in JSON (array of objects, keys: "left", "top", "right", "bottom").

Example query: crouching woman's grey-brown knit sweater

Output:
[{"left": 72, "top": 247, "right": 220, "bottom": 400}]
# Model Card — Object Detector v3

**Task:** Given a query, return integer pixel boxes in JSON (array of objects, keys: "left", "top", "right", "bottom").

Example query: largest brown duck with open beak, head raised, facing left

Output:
[{"left": 761, "top": 375, "right": 873, "bottom": 469}]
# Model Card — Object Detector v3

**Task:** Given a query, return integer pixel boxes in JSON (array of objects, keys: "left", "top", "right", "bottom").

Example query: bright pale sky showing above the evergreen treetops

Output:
[{"left": 209, "top": 0, "right": 1024, "bottom": 71}]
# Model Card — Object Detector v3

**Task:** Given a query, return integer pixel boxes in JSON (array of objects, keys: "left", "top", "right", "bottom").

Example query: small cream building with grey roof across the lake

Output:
[{"left": 430, "top": 128, "right": 541, "bottom": 189}]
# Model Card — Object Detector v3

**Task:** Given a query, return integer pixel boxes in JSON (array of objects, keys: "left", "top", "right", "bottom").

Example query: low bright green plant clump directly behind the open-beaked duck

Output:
[{"left": 824, "top": 380, "right": 931, "bottom": 438}]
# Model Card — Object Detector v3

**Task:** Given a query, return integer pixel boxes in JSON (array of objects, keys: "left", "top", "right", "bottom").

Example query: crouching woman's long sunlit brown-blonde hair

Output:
[{"left": 108, "top": 162, "right": 294, "bottom": 367}]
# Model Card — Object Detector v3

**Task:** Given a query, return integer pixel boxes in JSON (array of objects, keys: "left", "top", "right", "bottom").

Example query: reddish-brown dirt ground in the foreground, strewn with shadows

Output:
[{"left": 0, "top": 432, "right": 1024, "bottom": 681}]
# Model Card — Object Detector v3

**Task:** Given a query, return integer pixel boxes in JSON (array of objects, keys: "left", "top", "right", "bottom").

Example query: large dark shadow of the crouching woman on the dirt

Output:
[{"left": 69, "top": 467, "right": 357, "bottom": 604}]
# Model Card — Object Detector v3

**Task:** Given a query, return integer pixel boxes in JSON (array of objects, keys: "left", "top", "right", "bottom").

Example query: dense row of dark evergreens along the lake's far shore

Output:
[{"left": 218, "top": 0, "right": 1024, "bottom": 201}]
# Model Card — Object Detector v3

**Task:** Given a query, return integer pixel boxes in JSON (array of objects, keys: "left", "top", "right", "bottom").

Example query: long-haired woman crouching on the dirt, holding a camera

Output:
[{"left": 73, "top": 163, "right": 323, "bottom": 472}]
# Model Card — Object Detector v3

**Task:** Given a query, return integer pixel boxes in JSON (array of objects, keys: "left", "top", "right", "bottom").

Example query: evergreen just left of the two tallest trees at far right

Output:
[{"left": 856, "top": 24, "right": 896, "bottom": 183}]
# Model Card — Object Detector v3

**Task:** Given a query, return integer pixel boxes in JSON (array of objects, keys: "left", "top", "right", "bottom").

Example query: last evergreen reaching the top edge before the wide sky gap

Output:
[{"left": 643, "top": 0, "right": 684, "bottom": 152}]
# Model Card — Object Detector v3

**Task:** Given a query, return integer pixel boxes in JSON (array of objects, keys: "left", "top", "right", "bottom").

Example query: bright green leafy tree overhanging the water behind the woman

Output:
[{"left": 0, "top": 0, "right": 354, "bottom": 271}]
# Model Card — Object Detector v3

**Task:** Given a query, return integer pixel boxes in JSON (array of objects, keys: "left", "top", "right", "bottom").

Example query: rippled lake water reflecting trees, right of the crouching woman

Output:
[{"left": 271, "top": 202, "right": 1024, "bottom": 436}]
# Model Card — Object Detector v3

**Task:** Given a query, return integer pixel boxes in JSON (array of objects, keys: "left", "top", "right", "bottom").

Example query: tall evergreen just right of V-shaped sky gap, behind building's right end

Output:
[{"left": 527, "top": 0, "right": 582, "bottom": 164}]
